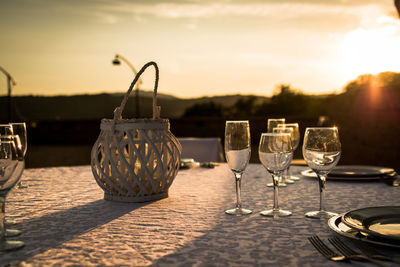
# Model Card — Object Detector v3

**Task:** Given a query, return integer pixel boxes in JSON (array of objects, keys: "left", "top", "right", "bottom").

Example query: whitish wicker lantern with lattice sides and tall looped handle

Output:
[{"left": 91, "top": 62, "right": 182, "bottom": 202}]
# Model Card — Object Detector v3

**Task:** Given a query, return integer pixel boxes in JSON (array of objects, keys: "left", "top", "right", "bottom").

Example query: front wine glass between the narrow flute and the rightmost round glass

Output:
[{"left": 258, "top": 133, "right": 293, "bottom": 217}]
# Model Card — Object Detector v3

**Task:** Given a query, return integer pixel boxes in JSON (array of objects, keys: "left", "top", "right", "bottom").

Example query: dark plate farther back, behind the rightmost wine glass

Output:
[{"left": 301, "top": 165, "right": 395, "bottom": 181}]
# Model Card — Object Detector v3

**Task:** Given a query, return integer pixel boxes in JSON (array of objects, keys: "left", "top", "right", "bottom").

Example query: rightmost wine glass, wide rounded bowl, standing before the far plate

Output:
[{"left": 303, "top": 127, "right": 341, "bottom": 219}]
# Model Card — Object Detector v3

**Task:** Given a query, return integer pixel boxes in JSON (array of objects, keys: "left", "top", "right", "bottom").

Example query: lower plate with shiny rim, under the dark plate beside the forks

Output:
[{"left": 328, "top": 214, "right": 400, "bottom": 248}]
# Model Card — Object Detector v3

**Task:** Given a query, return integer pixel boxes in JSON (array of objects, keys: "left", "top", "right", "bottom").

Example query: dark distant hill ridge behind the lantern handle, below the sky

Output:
[{"left": 0, "top": 91, "right": 268, "bottom": 122}]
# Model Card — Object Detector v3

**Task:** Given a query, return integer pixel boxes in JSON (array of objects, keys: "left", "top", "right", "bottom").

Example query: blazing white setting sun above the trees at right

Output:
[{"left": 340, "top": 25, "right": 400, "bottom": 79}]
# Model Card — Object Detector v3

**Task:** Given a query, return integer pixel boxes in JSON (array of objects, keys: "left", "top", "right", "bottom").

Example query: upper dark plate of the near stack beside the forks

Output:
[{"left": 342, "top": 206, "right": 400, "bottom": 244}]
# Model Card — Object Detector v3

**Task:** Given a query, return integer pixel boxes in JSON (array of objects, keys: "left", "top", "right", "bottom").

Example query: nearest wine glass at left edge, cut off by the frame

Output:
[{"left": 0, "top": 139, "right": 24, "bottom": 252}]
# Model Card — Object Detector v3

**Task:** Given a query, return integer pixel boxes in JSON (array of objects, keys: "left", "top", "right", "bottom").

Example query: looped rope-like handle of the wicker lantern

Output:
[{"left": 113, "top": 61, "right": 161, "bottom": 122}]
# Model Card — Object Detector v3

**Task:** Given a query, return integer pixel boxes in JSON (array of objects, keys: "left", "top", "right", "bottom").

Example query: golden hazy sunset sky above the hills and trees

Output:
[{"left": 0, "top": 0, "right": 400, "bottom": 97}]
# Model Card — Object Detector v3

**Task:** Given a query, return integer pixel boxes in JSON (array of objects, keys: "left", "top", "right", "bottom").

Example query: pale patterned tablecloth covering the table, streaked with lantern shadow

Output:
[{"left": 0, "top": 164, "right": 400, "bottom": 266}]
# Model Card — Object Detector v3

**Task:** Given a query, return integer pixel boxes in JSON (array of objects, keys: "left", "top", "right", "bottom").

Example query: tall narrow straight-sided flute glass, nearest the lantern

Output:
[{"left": 225, "top": 121, "right": 252, "bottom": 216}]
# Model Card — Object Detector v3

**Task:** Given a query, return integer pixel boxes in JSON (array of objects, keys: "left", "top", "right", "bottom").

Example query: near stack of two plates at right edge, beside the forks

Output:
[{"left": 328, "top": 206, "right": 400, "bottom": 248}]
